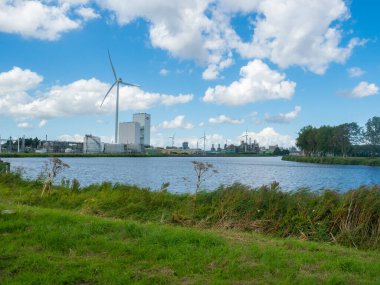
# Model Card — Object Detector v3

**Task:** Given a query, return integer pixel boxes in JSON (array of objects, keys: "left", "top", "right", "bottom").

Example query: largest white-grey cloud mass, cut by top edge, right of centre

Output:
[{"left": 97, "top": 0, "right": 364, "bottom": 79}]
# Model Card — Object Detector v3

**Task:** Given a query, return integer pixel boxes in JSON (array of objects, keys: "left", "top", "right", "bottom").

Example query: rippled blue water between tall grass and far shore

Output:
[{"left": 4, "top": 157, "right": 380, "bottom": 192}]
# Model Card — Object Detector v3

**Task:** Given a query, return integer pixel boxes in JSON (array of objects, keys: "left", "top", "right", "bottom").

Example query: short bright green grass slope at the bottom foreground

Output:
[{"left": 0, "top": 203, "right": 380, "bottom": 284}]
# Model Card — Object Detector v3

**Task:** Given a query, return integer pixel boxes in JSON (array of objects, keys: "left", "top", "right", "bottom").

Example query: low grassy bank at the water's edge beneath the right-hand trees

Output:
[{"left": 282, "top": 155, "right": 380, "bottom": 166}]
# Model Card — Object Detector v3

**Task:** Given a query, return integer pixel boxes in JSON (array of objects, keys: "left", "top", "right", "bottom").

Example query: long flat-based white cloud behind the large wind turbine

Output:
[{"left": 0, "top": 67, "right": 193, "bottom": 120}]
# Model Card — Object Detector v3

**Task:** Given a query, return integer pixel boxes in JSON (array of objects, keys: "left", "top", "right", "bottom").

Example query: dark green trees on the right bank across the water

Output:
[{"left": 296, "top": 116, "right": 380, "bottom": 157}]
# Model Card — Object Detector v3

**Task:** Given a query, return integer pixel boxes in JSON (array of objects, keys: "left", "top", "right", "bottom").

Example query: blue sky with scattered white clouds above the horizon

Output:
[{"left": 0, "top": 0, "right": 380, "bottom": 147}]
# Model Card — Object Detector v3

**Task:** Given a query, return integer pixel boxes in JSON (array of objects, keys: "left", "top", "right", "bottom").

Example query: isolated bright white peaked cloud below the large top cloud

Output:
[{"left": 203, "top": 60, "right": 296, "bottom": 106}]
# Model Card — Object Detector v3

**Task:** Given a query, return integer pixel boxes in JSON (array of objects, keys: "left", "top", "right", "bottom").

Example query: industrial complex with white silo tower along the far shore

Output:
[{"left": 0, "top": 113, "right": 296, "bottom": 155}]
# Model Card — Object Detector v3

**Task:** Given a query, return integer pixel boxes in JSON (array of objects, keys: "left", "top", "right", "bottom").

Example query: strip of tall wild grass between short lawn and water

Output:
[{"left": 0, "top": 171, "right": 380, "bottom": 249}]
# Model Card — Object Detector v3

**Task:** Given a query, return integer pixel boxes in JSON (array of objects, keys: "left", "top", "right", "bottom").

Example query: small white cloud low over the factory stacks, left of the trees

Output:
[{"left": 240, "top": 128, "right": 295, "bottom": 147}]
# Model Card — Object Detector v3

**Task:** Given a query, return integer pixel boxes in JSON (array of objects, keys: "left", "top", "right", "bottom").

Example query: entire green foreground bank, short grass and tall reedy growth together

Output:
[{"left": 0, "top": 174, "right": 380, "bottom": 284}]
